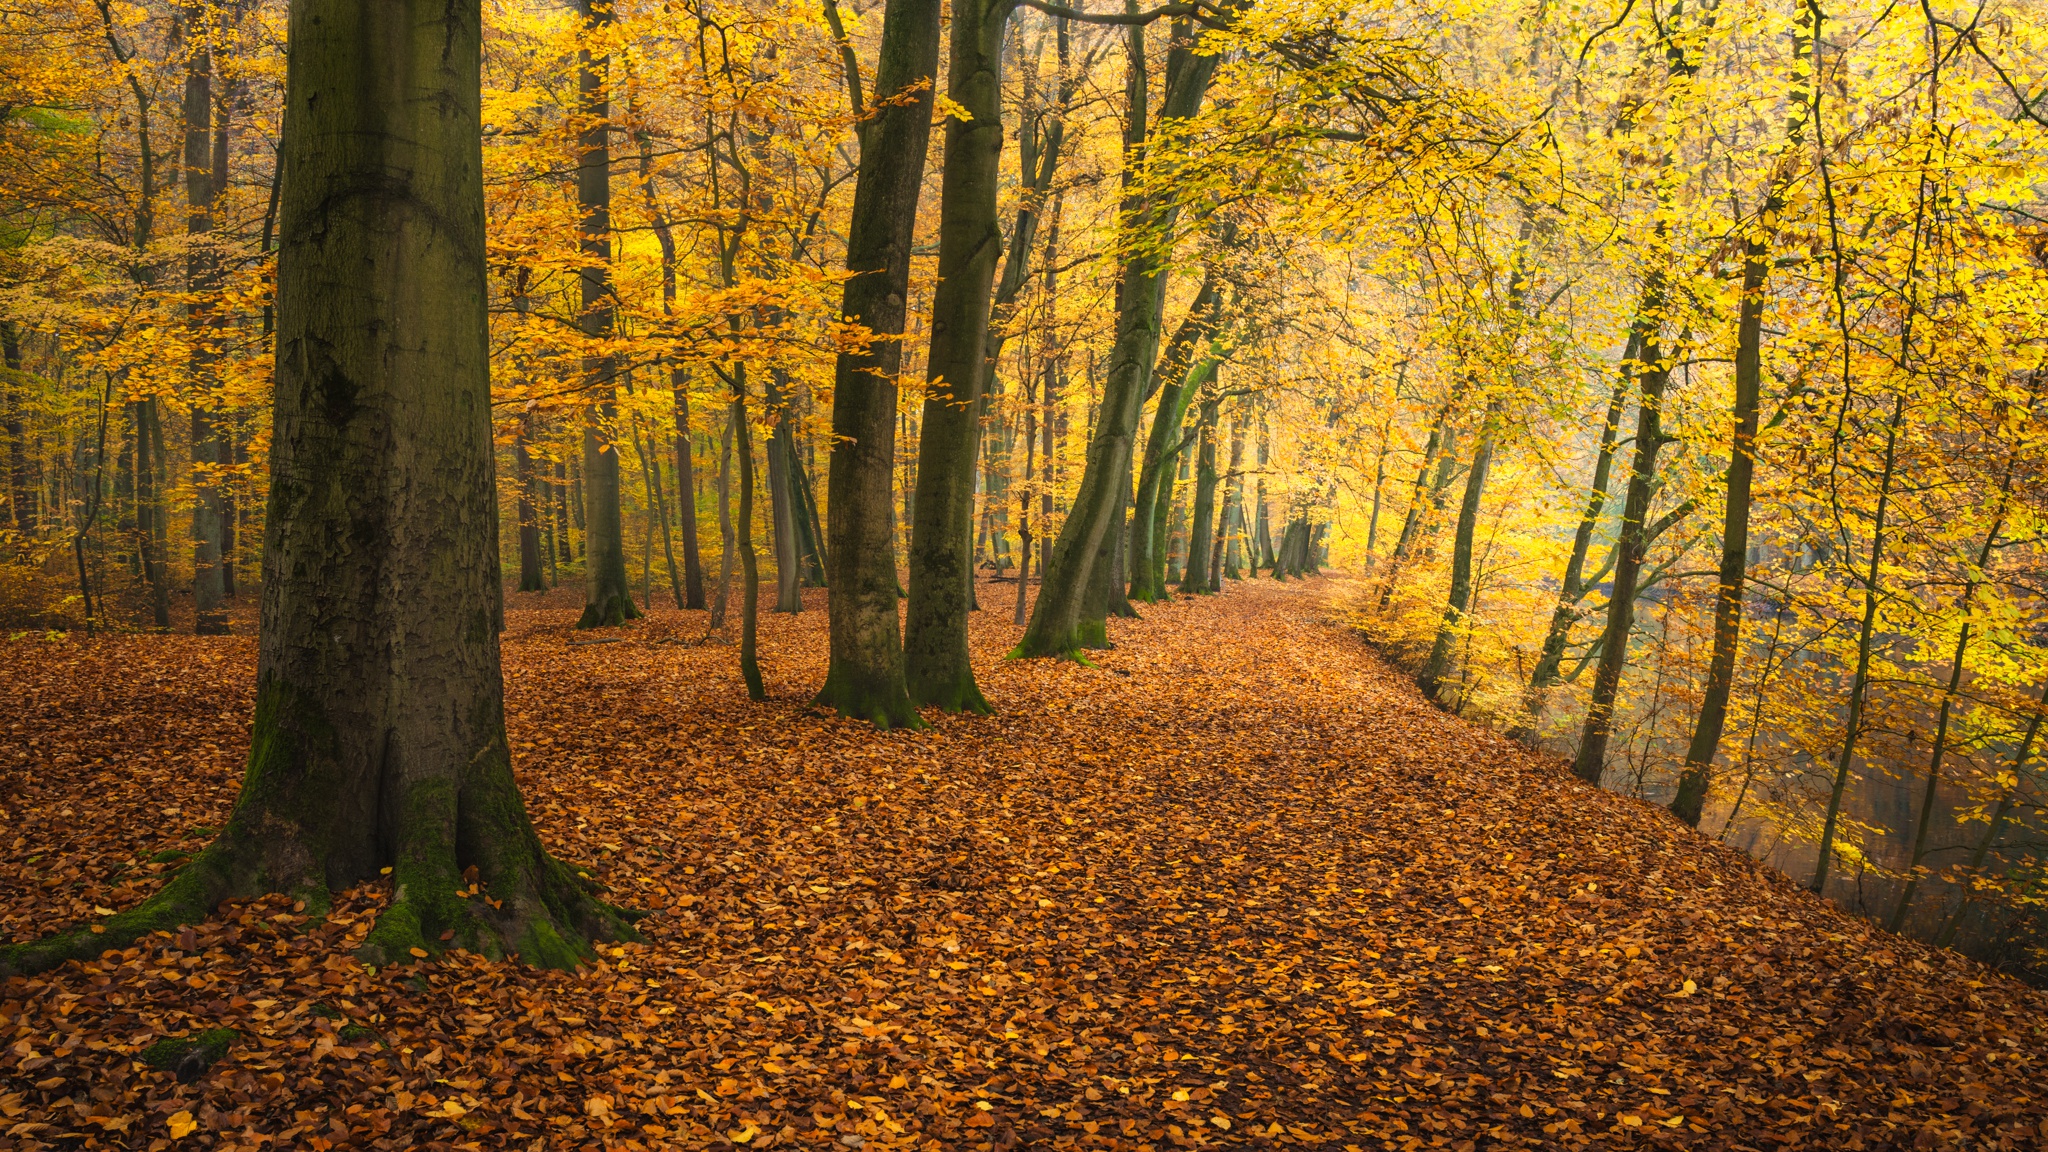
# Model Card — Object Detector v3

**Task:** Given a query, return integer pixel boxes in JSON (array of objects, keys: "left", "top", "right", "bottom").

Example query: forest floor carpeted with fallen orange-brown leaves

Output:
[{"left": 0, "top": 578, "right": 2048, "bottom": 1152}]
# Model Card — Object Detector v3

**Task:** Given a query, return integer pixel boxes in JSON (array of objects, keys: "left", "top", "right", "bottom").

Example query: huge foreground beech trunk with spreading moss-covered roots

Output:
[{"left": 0, "top": 0, "right": 631, "bottom": 974}]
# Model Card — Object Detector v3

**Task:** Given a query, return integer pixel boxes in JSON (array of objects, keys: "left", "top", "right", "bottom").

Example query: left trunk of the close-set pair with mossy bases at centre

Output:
[{"left": 817, "top": 0, "right": 942, "bottom": 728}]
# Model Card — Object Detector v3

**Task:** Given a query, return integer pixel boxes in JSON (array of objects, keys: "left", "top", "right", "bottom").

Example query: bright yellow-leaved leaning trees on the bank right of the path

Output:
[{"left": 1339, "top": 2, "right": 2048, "bottom": 972}]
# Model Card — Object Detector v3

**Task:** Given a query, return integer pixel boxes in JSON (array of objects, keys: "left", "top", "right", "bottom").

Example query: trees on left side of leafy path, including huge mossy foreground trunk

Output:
[{"left": 0, "top": 0, "right": 1376, "bottom": 970}]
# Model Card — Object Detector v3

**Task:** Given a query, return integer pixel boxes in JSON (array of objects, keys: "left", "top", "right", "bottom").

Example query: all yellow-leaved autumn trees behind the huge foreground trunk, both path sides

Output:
[{"left": 4, "top": 0, "right": 2048, "bottom": 975}]
